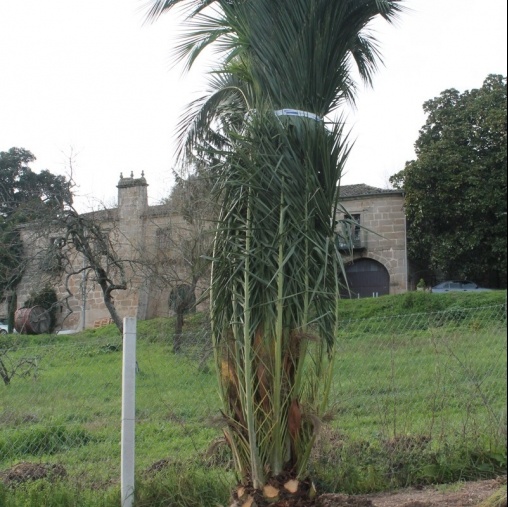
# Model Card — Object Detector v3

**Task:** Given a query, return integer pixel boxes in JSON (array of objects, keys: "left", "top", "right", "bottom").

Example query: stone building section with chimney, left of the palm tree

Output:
[{"left": 8, "top": 173, "right": 209, "bottom": 331}]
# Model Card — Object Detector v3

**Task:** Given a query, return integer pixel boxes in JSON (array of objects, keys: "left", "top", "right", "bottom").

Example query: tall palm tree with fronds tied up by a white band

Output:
[{"left": 145, "top": 0, "right": 401, "bottom": 500}]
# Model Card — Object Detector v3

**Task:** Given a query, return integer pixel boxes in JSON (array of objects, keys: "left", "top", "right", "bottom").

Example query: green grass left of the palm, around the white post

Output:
[{"left": 0, "top": 328, "right": 219, "bottom": 485}]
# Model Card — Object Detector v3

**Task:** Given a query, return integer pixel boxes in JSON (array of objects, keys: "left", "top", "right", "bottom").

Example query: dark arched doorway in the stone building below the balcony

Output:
[{"left": 343, "top": 259, "right": 390, "bottom": 298}]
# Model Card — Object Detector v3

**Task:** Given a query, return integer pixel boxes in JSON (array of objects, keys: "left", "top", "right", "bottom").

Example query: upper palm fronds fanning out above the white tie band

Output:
[{"left": 147, "top": 0, "right": 403, "bottom": 112}]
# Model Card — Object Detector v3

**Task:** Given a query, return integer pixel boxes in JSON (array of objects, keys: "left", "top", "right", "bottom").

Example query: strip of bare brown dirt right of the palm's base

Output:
[{"left": 318, "top": 477, "right": 506, "bottom": 507}]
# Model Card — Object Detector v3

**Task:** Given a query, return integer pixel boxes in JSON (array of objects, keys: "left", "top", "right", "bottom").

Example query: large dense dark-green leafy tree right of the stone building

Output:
[{"left": 390, "top": 75, "right": 507, "bottom": 286}]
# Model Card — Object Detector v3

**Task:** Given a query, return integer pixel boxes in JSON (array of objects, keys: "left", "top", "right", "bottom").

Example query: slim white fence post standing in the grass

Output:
[{"left": 121, "top": 317, "right": 136, "bottom": 507}]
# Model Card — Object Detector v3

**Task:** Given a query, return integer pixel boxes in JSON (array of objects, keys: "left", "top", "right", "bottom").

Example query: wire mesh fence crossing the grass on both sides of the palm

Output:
[{"left": 0, "top": 305, "right": 507, "bottom": 487}]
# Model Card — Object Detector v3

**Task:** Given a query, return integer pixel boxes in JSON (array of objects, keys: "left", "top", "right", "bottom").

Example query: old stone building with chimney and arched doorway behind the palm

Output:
[{"left": 0, "top": 177, "right": 408, "bottom": 331}]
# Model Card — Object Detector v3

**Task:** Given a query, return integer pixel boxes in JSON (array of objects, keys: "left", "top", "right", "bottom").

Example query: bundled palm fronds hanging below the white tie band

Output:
[{"left": 208, "top": 104, "right": 349, "bottom": 480}]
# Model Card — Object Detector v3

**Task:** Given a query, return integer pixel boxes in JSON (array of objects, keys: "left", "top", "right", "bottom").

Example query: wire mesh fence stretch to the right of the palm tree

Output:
[{"left": 333, "top": 305, "right": 506, "bottom": 443}]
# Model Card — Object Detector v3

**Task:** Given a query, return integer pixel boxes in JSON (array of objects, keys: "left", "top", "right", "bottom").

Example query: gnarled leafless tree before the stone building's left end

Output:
[{"left": 14, "top": 199, "right": 136, "bottom": 338}]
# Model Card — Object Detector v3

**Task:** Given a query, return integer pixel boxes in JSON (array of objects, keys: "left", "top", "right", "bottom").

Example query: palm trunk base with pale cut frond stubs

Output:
[{"left": 230, "top": 474, "right": 319, "bottom": 507}]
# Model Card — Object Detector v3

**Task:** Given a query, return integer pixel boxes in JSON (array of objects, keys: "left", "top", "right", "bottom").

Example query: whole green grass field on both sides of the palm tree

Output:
[{"left": 0, "top": 291, "right": 506, "bottom": 507}]
